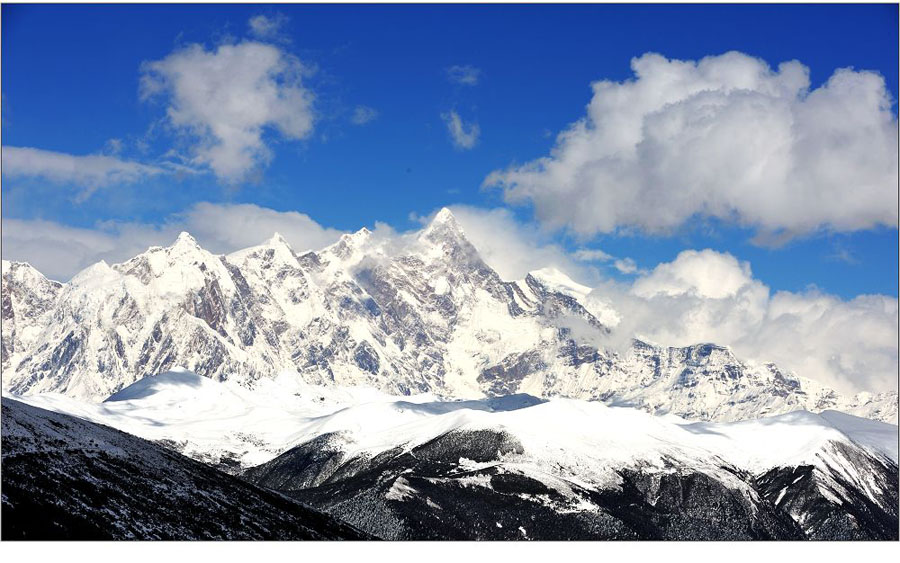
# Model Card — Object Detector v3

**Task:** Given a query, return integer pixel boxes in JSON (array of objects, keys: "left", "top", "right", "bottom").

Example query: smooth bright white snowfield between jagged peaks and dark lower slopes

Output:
[{"left": 14, "top": 370, "right": 898, "bottom": 485}]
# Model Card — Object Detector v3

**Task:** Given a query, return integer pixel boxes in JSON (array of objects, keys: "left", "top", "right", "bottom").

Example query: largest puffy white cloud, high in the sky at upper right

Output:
[{"left": 485, "top": 52, "right": 898, "bottom": 243}]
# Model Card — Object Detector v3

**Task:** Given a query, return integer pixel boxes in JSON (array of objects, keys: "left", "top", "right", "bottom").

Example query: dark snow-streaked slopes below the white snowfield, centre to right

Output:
[{"left": 244, "top": 430, "right": 898, "bottom": 540}]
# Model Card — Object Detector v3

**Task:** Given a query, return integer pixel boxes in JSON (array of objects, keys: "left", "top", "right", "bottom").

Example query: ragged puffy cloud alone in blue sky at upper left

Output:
[{"left": 141, "top": 41, "right": 315, "bottom": 183}]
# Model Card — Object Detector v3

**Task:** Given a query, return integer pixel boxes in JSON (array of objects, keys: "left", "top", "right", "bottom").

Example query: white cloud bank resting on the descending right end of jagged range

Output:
[{"left": 589, "top": 250, "right": 898, "bottom": 392}]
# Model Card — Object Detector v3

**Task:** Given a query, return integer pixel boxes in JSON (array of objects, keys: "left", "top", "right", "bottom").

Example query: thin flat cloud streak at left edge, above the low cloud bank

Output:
[{"left": 2, "top": 146, "right": 166, "bottom": 197}]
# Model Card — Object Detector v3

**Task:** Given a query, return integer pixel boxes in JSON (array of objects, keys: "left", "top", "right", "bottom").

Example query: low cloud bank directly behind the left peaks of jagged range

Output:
[{"left": 3, "top": 202, "right": 342, "bottom": 281}]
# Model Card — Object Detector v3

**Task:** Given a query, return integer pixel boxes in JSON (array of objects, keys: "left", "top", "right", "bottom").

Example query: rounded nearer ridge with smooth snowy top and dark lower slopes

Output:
[{"left": 14, "top": 371, "right": 898, "bottom": 539}]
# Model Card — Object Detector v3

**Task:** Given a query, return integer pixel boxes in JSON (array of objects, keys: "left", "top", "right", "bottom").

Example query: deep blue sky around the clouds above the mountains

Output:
[{"left": 2, "top": 5, "right": 898, "bottom": 299}]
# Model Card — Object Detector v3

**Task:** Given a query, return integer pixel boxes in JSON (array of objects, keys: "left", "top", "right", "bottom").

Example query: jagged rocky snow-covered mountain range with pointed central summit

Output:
[{"left": 3, "top": 209, "right": 897, "bottom": 422}]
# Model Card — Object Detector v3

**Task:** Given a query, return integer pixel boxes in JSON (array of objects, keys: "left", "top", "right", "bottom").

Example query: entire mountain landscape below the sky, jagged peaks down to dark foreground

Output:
[{"left": 2, "top": 209, "right": 898, "bottom": 540}]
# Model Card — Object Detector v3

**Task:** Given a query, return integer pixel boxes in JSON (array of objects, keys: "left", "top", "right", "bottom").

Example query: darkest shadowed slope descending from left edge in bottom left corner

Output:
[{"left": 2, "top": 398, "right": 368, "bottom": 540}]
